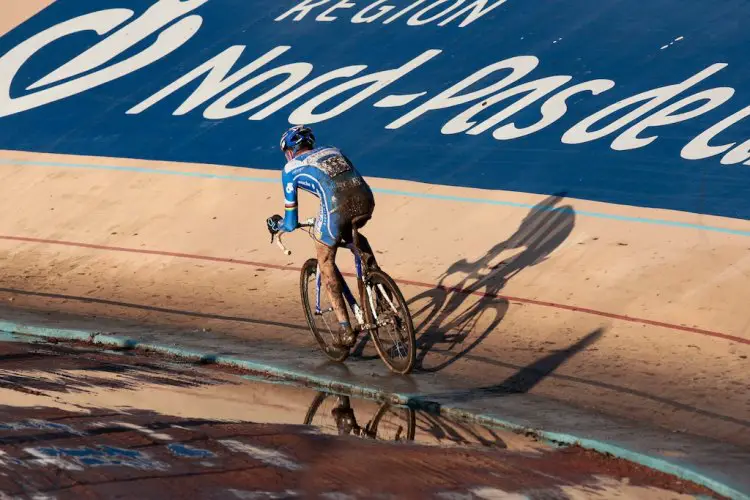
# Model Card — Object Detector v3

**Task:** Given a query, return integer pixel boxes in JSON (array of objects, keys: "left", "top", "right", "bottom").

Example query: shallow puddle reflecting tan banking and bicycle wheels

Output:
[{"left": 0, "top": 336, "right": 550, "bottom": 452}]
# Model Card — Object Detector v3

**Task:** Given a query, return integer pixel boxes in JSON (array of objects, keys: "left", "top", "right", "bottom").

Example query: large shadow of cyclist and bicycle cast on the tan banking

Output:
[{"left": 408, "top": 193, "right": 575, "bottom": 372}]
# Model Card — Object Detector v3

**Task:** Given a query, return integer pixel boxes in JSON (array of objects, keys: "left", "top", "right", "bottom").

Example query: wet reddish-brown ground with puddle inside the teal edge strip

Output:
[{"left": 0, "top": 337, "right": 724, "bottom": 499}]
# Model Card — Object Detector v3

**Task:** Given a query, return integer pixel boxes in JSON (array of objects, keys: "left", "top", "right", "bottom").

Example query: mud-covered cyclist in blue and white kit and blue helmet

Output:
[{"left": 266, "top": 125, "right": 377, "bottom": 347}]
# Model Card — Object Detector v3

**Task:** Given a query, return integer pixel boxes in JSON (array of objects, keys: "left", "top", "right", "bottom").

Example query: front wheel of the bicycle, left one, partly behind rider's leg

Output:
[{"left": 300, "top": 259, "right": 349, "bottom": 362}]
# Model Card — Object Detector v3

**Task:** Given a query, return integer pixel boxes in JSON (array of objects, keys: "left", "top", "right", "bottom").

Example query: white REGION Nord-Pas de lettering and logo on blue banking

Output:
[{"left": 0, "top": 0, "right": 750, "bottom": 175}]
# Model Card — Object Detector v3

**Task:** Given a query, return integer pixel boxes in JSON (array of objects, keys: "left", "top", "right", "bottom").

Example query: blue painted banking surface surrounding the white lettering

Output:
[{"left": 0, "top": 0, "right": 750, "bottom": 219}]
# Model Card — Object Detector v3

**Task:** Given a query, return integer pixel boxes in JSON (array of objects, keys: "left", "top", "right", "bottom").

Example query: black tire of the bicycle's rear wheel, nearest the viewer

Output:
[{"left": 362, "top": 270, "right": 417, "bottom": 375}]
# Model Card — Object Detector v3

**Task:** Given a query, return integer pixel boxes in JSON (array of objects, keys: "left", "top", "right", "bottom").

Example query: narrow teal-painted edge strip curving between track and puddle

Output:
[{"left": 0, "top": 321, "right": 750, "bottom": 500}]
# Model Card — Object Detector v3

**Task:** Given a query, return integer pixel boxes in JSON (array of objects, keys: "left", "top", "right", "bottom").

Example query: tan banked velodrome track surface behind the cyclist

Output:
[{"left": 0, "top": 0, "right": 750, "bottom": 454}]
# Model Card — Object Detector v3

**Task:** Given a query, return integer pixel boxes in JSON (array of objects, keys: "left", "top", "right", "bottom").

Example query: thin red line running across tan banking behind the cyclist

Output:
[{"left": 0, "top": 235, "right": 750, "bottom": 345}]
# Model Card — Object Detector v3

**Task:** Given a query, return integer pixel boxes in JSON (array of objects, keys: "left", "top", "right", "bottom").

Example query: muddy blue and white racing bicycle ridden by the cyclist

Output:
[{"left": 271, "top": 218, "right": 417, "bottom": 375}]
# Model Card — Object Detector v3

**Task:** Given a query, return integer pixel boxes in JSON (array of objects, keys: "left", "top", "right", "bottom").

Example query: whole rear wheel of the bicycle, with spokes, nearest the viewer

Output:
[{"left": 364, "top": 270, "right": 417, "bottom": 375}]
